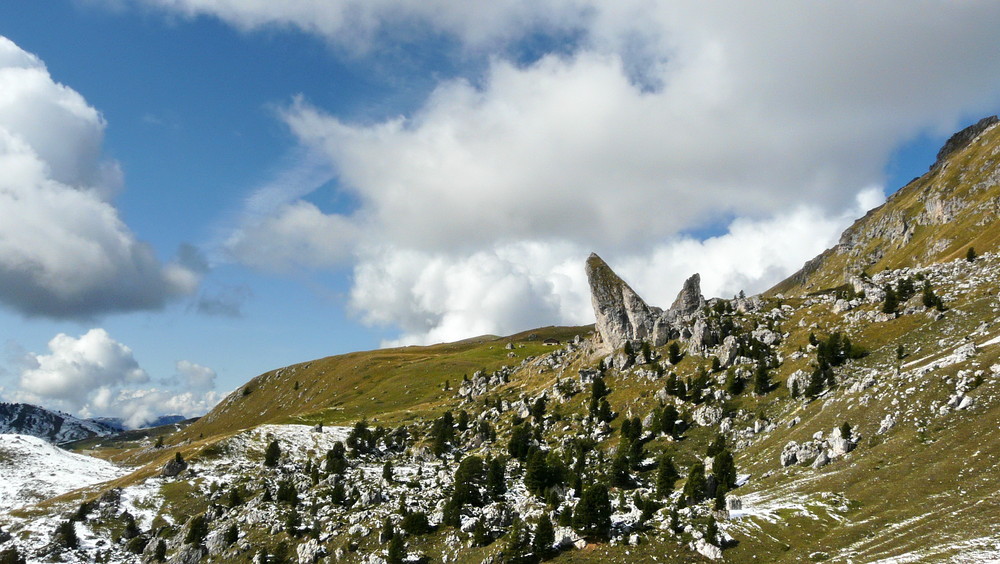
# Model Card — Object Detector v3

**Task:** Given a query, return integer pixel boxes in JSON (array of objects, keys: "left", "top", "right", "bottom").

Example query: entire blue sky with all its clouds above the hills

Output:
[{"left": 0, "top": 0, "right": 1000, "bottom": 424}]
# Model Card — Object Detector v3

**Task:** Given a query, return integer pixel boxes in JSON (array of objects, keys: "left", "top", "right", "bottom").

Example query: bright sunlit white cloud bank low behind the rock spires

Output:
[{"left": 351, "top": 187, "right": 884, "bottom": 346}]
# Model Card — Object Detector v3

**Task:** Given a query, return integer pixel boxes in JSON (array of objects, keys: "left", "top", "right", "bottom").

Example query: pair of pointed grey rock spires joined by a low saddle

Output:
[{"left": 586, "top": 253, "right": 705, "bottom": 350}]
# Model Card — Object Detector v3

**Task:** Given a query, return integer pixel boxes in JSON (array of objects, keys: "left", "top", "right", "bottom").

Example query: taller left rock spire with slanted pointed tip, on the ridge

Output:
[{"left": 587, "top": 253, "right": 661, "bottom": 350}]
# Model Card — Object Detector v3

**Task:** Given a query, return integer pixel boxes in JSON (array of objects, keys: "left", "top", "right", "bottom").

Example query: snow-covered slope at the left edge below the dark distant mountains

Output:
[{"left": 0, "top": 435, "right": 127, "bottom": 513}]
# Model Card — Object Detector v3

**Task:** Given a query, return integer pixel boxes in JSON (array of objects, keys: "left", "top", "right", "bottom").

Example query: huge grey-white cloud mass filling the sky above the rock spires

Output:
[{"left": 139, "top": 0, "right": 1000, "bottom": 342}]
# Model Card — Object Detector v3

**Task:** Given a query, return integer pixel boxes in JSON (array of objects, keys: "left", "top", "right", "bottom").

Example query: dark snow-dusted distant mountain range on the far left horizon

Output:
[{"left": 0, "top": 403, "right": 184, "bottom": 445}]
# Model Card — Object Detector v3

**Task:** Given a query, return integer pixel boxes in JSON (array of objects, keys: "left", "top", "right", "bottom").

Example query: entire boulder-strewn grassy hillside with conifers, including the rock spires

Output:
[{"left": 0, "top": 123, "right": 1000, "bottom": 564}]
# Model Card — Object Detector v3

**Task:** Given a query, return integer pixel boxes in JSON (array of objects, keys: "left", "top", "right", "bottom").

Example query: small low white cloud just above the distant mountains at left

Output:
[{"left": 6, "top": 328, "right": 223, "bottom": 427}]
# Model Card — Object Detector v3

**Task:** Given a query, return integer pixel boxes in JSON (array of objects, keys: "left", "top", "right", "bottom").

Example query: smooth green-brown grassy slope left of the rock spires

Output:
[{"left": 176, "top": 326, "right": 593, "bottom": 450}]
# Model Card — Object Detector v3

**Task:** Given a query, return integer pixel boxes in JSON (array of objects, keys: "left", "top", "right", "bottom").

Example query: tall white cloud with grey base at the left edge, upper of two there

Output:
[{"left": 0, "top": 37, "right": 198, "bottom": 318}]
